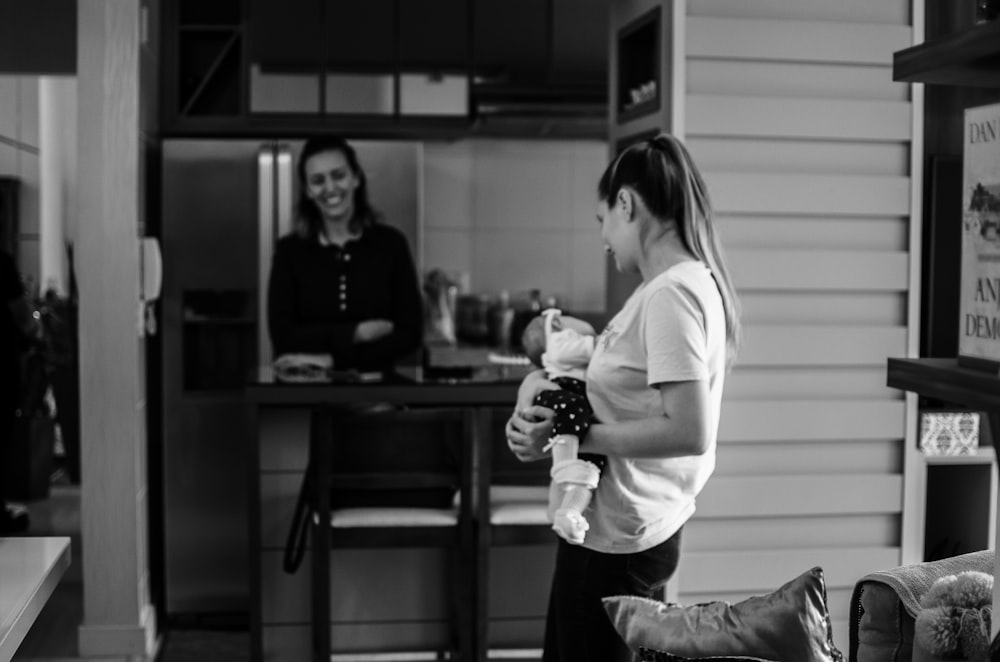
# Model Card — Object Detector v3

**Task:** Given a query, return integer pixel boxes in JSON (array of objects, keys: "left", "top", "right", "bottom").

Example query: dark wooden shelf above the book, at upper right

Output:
[{"left": 892, "top": 20, "right": 1000, "bottom": 87}]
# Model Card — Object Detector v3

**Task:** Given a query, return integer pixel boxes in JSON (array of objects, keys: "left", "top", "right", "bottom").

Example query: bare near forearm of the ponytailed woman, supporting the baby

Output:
[{"left": 580, "top": 415, "right": 709, "bottom": 459}]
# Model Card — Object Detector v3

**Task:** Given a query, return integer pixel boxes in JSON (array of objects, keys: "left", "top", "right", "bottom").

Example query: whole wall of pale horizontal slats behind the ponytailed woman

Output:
[{"left": 668, "top": 0, "right": 913, "bottom": 650}]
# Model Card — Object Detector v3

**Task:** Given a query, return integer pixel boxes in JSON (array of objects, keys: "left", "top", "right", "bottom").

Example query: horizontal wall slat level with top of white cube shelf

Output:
[{"left": 715, "top": 439, "right": 903, "bottom": 477}]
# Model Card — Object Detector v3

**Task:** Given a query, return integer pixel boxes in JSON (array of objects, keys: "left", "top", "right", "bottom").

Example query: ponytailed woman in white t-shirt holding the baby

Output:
[{"left": 506, "top": 134, "right": 740, "bottom": 662}]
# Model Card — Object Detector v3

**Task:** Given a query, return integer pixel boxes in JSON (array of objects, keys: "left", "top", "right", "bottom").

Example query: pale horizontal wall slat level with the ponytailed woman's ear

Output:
[{"left": 706, "top": 172, "right": 910, "bottom": 217}]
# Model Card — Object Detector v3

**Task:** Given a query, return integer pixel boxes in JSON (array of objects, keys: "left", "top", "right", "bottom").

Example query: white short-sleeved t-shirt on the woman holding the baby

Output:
[{"left": 584, "top": 261, "right": 726, "bottom": 554}]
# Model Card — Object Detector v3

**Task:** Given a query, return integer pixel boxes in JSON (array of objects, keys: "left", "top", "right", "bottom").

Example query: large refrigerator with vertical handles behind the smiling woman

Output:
[{"left": 159, "top": 139, "right": 423, "bottom": 616}]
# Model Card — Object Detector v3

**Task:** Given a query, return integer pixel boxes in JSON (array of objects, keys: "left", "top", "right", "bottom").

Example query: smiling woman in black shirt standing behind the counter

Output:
[{"left": 267, "top": 137, "right": 423, "bottom": 370}]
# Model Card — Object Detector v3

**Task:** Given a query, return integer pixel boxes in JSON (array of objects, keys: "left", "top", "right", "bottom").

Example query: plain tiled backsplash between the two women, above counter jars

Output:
[{"left": 420, "top": 140, "right": 607, "bottom": 311}]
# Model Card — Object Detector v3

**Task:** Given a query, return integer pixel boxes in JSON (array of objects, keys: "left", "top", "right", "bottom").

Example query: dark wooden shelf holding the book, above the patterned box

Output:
[{"left": 886, "top": 359, "right": 1000, "bottom": 413}]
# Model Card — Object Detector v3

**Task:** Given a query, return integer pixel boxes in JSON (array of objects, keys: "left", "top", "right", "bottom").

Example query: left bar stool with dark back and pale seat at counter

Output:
[{"left": 310, "top": 408, "right": 474, "bottom": 662}]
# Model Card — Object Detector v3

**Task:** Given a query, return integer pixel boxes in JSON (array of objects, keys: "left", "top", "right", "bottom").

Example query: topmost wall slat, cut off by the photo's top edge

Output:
[{"left": 687, "top": 0, "right": 910, "bottom": 25}]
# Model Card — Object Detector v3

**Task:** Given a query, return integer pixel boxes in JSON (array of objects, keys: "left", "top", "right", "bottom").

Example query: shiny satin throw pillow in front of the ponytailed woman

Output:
[{"left": 604, "top": 567, "right": 844, "bottom": 662}]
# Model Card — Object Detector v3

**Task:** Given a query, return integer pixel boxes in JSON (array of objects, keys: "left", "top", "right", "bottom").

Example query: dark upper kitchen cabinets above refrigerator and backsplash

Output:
[{"left": 162, "top": 0, "right": 608, "bottom": 136}]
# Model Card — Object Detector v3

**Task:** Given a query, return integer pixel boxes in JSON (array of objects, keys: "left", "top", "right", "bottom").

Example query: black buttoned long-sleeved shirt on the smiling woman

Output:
[{"left": 267, "top": 223, "right": 423, "bottom": 370}]
